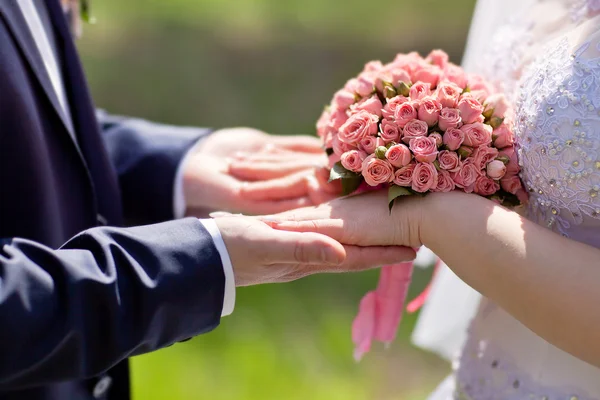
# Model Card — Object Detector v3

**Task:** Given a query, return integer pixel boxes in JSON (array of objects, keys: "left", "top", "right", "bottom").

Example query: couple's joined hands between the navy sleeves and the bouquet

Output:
[{"left": 184, "top": 128, "right": 421, "bottom": 286}]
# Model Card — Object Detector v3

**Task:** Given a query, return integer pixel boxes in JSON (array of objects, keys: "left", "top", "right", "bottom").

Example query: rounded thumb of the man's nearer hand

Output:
[{"left": 267, "top": 228, "right": 346, "bottom": 267}]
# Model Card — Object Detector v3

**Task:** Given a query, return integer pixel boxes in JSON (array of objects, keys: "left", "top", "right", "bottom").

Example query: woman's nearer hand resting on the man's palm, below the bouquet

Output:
[{"left": 262, "top": 191, "right": 431, "bottom": 248}]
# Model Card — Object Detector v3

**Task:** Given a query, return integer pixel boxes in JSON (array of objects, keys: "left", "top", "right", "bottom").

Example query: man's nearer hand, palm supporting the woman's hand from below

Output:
[{"left": 215, "top": 216, "right": 415, "bottom": 286}]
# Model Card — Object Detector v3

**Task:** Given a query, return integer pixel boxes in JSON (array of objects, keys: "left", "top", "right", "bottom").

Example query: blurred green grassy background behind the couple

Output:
[{"left": 79, "top": 0, "right": 474, "bottom": 400}]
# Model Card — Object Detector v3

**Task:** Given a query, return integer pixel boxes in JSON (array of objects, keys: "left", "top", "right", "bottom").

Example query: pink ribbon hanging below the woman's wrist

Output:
[{"left": 352, "top": 255, "right": 441, "bottom": 361}]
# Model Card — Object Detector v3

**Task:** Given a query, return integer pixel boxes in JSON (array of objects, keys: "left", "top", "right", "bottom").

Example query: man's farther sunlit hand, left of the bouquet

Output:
[{"left": 184, "top": 128, "right": 336, "bottom": 215}]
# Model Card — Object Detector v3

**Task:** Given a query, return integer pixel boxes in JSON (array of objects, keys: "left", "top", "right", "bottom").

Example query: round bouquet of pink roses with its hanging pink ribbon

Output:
[{"left": 317, "top": 50, "right": 525, "bottom": 358}]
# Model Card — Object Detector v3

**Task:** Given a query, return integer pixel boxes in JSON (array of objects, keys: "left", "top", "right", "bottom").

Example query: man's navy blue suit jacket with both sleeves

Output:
[{"left": 0, "top": 0, "right": 225, "bottom": 400}]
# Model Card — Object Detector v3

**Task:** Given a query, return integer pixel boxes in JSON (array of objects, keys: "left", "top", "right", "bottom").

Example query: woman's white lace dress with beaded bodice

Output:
[{"left": 430, "top": 0, "right": 600, "bottom": 400}]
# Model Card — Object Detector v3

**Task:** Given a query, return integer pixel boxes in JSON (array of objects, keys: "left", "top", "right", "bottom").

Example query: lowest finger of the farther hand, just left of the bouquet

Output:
[{"left": 240, "top": 172, "right": 308, "bottom": 200}]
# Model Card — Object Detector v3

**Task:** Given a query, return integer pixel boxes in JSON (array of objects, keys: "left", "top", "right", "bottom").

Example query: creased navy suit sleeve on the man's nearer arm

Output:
[{"left": 0, "top": 218, "right": 225, "bottom": 390}]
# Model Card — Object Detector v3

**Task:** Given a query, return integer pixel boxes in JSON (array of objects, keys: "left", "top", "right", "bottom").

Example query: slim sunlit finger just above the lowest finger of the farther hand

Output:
[{"left": 228, "top": 158, "right": 322, "bottom": 181}]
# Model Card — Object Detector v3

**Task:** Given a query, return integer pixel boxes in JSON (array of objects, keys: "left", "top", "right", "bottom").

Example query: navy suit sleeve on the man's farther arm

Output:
[{"left": 97, "top": 111, "right": 216, "bottom": 225}]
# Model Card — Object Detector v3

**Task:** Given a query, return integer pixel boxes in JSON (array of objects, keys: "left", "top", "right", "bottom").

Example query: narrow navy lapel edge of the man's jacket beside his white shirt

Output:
[{"left": 0, "top": 0, "right": 77, "bottom": 142}]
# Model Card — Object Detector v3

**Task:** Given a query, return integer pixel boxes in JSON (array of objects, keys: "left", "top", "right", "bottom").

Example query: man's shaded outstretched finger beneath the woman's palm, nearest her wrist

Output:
[{"left": 307, "top": 246, "right": 416, "bottom": 274}]
